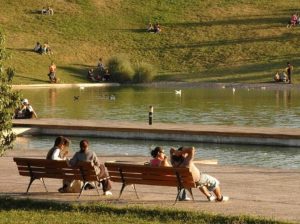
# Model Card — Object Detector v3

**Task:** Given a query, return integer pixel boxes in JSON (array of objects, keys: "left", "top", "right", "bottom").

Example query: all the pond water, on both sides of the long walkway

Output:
[{"left": 16, "top": 87, "right": 300, "bottom": 169}]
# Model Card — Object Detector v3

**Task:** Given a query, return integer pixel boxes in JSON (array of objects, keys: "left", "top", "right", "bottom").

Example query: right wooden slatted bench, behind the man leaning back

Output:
[{"left": 105, "top": 162, "right": 196, "bottom": 204}]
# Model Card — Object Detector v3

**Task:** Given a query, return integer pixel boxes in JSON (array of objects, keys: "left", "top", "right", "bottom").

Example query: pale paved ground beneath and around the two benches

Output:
[{"left": 0, "top": 150, "right": 300, "bottom": 223}]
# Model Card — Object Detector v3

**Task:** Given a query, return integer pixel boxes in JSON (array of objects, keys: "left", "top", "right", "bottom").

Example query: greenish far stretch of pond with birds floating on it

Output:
[{"left": 18, "top": 87, "right": 300, "bottom": 128}]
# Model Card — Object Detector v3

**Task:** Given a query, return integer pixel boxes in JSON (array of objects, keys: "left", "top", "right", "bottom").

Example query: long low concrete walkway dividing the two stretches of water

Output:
[{"left": 13, "top": 119, "right": 300, "bottom": 146}]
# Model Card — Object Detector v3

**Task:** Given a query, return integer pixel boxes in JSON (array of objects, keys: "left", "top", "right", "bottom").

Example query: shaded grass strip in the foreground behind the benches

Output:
[{"left": 0, "top": 197, "right": 292, "bottom": 224}]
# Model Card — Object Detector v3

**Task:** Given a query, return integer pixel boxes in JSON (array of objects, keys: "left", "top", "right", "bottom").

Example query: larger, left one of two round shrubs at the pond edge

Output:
[{"left": 107, "top": 56, "right": 134, "bottom": 83}]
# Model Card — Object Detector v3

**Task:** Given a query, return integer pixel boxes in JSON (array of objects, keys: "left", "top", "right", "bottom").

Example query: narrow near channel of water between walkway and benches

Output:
[{"left": 15, "top": 136, "right": 300, "bottom": 169}]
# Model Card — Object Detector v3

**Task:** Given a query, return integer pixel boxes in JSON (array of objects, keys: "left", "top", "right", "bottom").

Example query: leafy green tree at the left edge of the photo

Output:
[{"left": 0, "top": 31, "right": 20, "bottom": 156}]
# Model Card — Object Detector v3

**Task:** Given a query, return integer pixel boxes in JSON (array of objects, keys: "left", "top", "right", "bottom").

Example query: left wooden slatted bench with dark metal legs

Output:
[{"left": 13, "top": 157, "right": 102, "bottom": 199}]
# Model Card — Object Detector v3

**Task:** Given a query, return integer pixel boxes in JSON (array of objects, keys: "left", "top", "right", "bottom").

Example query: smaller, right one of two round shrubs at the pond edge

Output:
[{"left": 133, "top": 63, "right": 156, "bottom": 83}]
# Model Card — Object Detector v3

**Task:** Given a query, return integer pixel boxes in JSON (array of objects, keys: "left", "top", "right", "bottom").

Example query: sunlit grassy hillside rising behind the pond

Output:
[{"left": 0, "top": 0, "right": 300, "bottom": 84}]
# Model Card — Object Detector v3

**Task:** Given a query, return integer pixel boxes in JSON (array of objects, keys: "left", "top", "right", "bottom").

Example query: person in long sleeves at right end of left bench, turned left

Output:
[{"left": 69, "top": 140, "right": 112, "bottom": 196}]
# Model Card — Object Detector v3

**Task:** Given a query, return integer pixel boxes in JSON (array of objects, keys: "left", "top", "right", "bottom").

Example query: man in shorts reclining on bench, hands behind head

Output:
[{"left": 170, "top": 147, "right": 229, "bottom": 202}]
